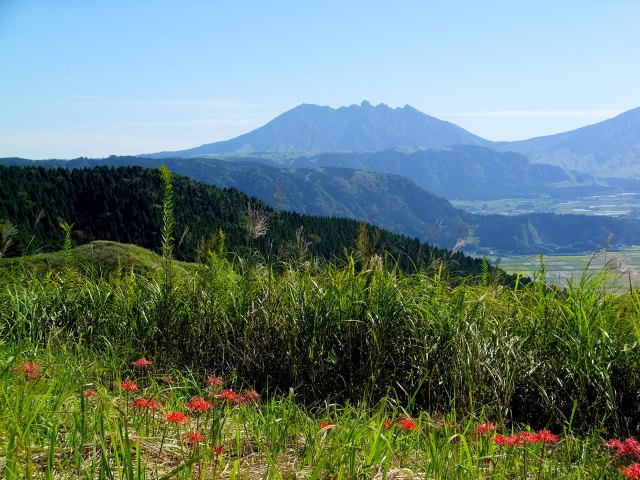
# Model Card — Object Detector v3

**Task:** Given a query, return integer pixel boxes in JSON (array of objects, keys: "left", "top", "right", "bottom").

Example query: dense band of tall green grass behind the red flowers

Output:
[{"left": 0, "top": 248, "right": 640, "bottom": 432}]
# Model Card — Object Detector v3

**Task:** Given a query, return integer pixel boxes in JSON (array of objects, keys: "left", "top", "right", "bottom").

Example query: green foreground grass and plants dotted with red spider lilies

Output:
[{"left": 0, "top": 166, "right": 640, "bottom": 479}]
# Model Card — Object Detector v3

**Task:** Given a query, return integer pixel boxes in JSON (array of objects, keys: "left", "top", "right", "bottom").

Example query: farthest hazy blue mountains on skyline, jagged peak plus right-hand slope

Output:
[{"left": 139, "top": 100, "right": 640, "bottom": 178}]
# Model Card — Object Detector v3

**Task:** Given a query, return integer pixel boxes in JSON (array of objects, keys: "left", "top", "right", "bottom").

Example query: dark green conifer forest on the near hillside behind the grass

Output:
[{"left": 0, "top": 166, "right": 504, "bottom": 277}]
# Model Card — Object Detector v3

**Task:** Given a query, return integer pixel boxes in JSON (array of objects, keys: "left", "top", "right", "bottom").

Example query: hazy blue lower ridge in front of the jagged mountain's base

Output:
[{"left": 293, "top": 145, "right": 594, "bottom": 200}]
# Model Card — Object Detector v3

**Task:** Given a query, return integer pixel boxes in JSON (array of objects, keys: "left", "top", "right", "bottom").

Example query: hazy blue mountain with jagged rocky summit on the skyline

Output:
[{"left": 143, "top": 101, "right": 492, "bottom": 158}]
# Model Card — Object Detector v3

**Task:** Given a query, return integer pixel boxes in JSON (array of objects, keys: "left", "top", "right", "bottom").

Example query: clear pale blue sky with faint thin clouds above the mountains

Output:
[{"left": 0, "top": 0, "right": 640, "bottom": 158}]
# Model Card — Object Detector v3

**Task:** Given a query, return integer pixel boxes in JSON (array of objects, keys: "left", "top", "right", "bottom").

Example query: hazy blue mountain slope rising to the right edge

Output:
[{"left": 492, "top": 107, "right": 640, "bottom": 178}]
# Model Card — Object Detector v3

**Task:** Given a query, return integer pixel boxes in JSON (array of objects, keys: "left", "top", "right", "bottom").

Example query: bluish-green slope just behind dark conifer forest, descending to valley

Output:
[{"left": 0, "top": 157, "right": 469, "bottom": 248}]
